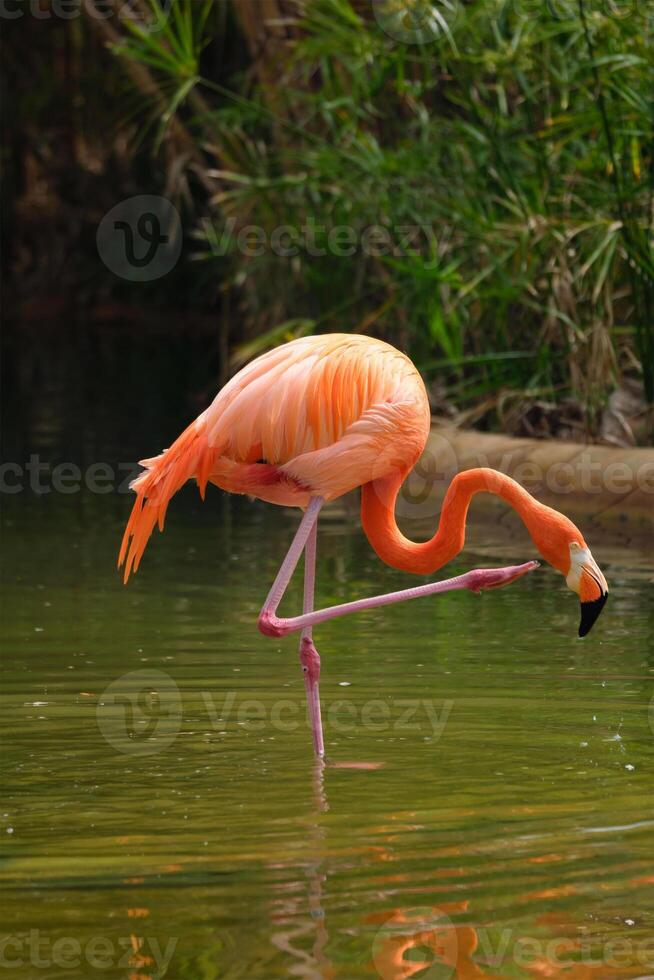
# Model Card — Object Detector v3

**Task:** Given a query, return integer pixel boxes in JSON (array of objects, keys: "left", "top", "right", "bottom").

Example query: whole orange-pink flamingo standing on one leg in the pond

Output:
[{"left": 118, "top": 334, "right": 608, "bottom": 758}]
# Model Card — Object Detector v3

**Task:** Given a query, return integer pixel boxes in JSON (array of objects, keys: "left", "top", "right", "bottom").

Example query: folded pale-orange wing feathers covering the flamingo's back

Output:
[{"left": 203, "top": 334, "right": 429, "bottom": 493}]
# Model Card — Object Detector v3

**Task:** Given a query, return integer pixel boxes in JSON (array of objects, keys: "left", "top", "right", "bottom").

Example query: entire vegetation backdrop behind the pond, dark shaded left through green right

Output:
[{"left": 0, "top": 0, "right": 654, "bottom": 445}]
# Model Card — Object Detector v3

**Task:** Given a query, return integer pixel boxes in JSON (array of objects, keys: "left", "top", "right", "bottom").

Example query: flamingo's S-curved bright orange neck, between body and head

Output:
[{"left": 361, "top": 468, "right": 560, "bottom": 575}]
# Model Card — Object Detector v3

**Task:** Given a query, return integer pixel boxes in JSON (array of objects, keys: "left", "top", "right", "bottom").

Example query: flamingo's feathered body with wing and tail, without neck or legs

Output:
[{"left": 120, "top": 334, "right": 430, "bottom": 581}]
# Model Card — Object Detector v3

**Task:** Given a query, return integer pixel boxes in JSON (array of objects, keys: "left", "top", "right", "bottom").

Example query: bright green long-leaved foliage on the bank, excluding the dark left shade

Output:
[{"left": 101, "top": 0, "right": 654, "bottom": 427}]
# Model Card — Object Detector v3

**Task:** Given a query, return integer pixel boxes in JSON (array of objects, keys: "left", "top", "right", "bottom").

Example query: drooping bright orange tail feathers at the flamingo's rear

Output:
[{"left": 118, "top": 422, "right": 217, "bottom": 582}]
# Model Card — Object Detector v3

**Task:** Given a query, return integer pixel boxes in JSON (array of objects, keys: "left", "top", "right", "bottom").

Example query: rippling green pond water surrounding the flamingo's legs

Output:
[{"left": 0, "top": 486, "right": 654, "bottom": 980}]
